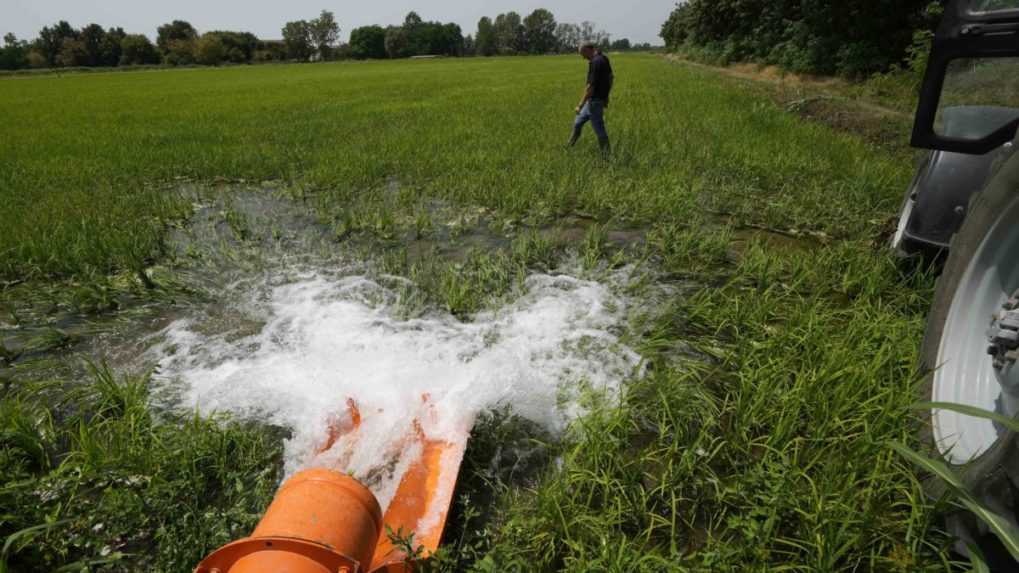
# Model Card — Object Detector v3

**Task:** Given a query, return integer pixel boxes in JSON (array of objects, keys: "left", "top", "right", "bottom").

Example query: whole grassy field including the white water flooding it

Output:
[{"left": 0, "top": 55, "right": 949, "bottom": 572}]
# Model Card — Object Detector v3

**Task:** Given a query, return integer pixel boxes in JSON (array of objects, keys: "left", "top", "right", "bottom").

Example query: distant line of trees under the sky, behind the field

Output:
[{"left": 0, "top": 8, "right": 651, "bottom": 69}]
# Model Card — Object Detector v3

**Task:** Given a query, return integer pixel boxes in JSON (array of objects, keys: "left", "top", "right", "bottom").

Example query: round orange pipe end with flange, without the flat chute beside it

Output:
[{"left": 195, "top": 469, "right": 382, "bottom": 573}]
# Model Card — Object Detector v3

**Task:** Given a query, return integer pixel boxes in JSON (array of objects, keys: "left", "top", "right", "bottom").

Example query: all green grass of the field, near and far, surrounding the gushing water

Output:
[{"left": 0, "top": 55, "right": 950, "bottom": 572}]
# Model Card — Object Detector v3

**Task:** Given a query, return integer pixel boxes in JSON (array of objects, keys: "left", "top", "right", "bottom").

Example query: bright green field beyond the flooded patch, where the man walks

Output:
[{"left": 0, "top": 56, "right": 908, "bottom": 277}]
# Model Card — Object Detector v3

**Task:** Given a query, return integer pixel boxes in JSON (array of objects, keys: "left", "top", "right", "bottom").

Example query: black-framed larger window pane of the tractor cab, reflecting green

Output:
[{"left": 934, "top": 56, "right": 1019, "bottom": 141}]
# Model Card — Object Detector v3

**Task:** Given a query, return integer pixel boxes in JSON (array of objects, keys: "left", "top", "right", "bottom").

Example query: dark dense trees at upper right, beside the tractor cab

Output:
[{"left": 660, "top": 0, "right": 941, "bottom": 77}]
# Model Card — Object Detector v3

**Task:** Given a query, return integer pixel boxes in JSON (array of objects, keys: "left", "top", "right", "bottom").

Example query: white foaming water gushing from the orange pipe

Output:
[{"left": 148, "top": 272, "right": 640, "bottom": 507}]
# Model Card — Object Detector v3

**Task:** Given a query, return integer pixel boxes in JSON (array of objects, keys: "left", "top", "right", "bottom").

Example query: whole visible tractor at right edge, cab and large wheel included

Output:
[{"left": 893, "top": 0, "right": 1019, "bottom": 571}]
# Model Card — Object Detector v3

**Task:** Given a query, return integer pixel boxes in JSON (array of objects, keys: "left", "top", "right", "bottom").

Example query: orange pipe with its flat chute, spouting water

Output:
[{"left": 196, "top": 395, "right": 468, "bottom": 573}]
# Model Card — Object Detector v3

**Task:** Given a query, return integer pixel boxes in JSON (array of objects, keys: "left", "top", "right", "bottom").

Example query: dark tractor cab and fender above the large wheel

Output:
[{"left": 893, "top": 0, "right": 1019, "bottom": 253}]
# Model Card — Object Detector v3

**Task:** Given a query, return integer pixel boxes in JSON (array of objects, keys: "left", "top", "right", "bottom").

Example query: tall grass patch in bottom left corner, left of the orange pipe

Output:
[{"left": 0, "top": 366, "right": 282, "bottom": 571}]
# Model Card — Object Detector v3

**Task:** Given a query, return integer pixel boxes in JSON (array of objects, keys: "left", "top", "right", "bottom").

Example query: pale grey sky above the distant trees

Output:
[{"left": 0, "top": 0, "right": 676, "bottom": 44}]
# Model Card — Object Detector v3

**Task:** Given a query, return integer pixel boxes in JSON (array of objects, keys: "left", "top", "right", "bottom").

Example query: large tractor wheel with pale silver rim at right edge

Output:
[{"left": 922, "top": 157, "right": 1019, "bottom": 571}]
